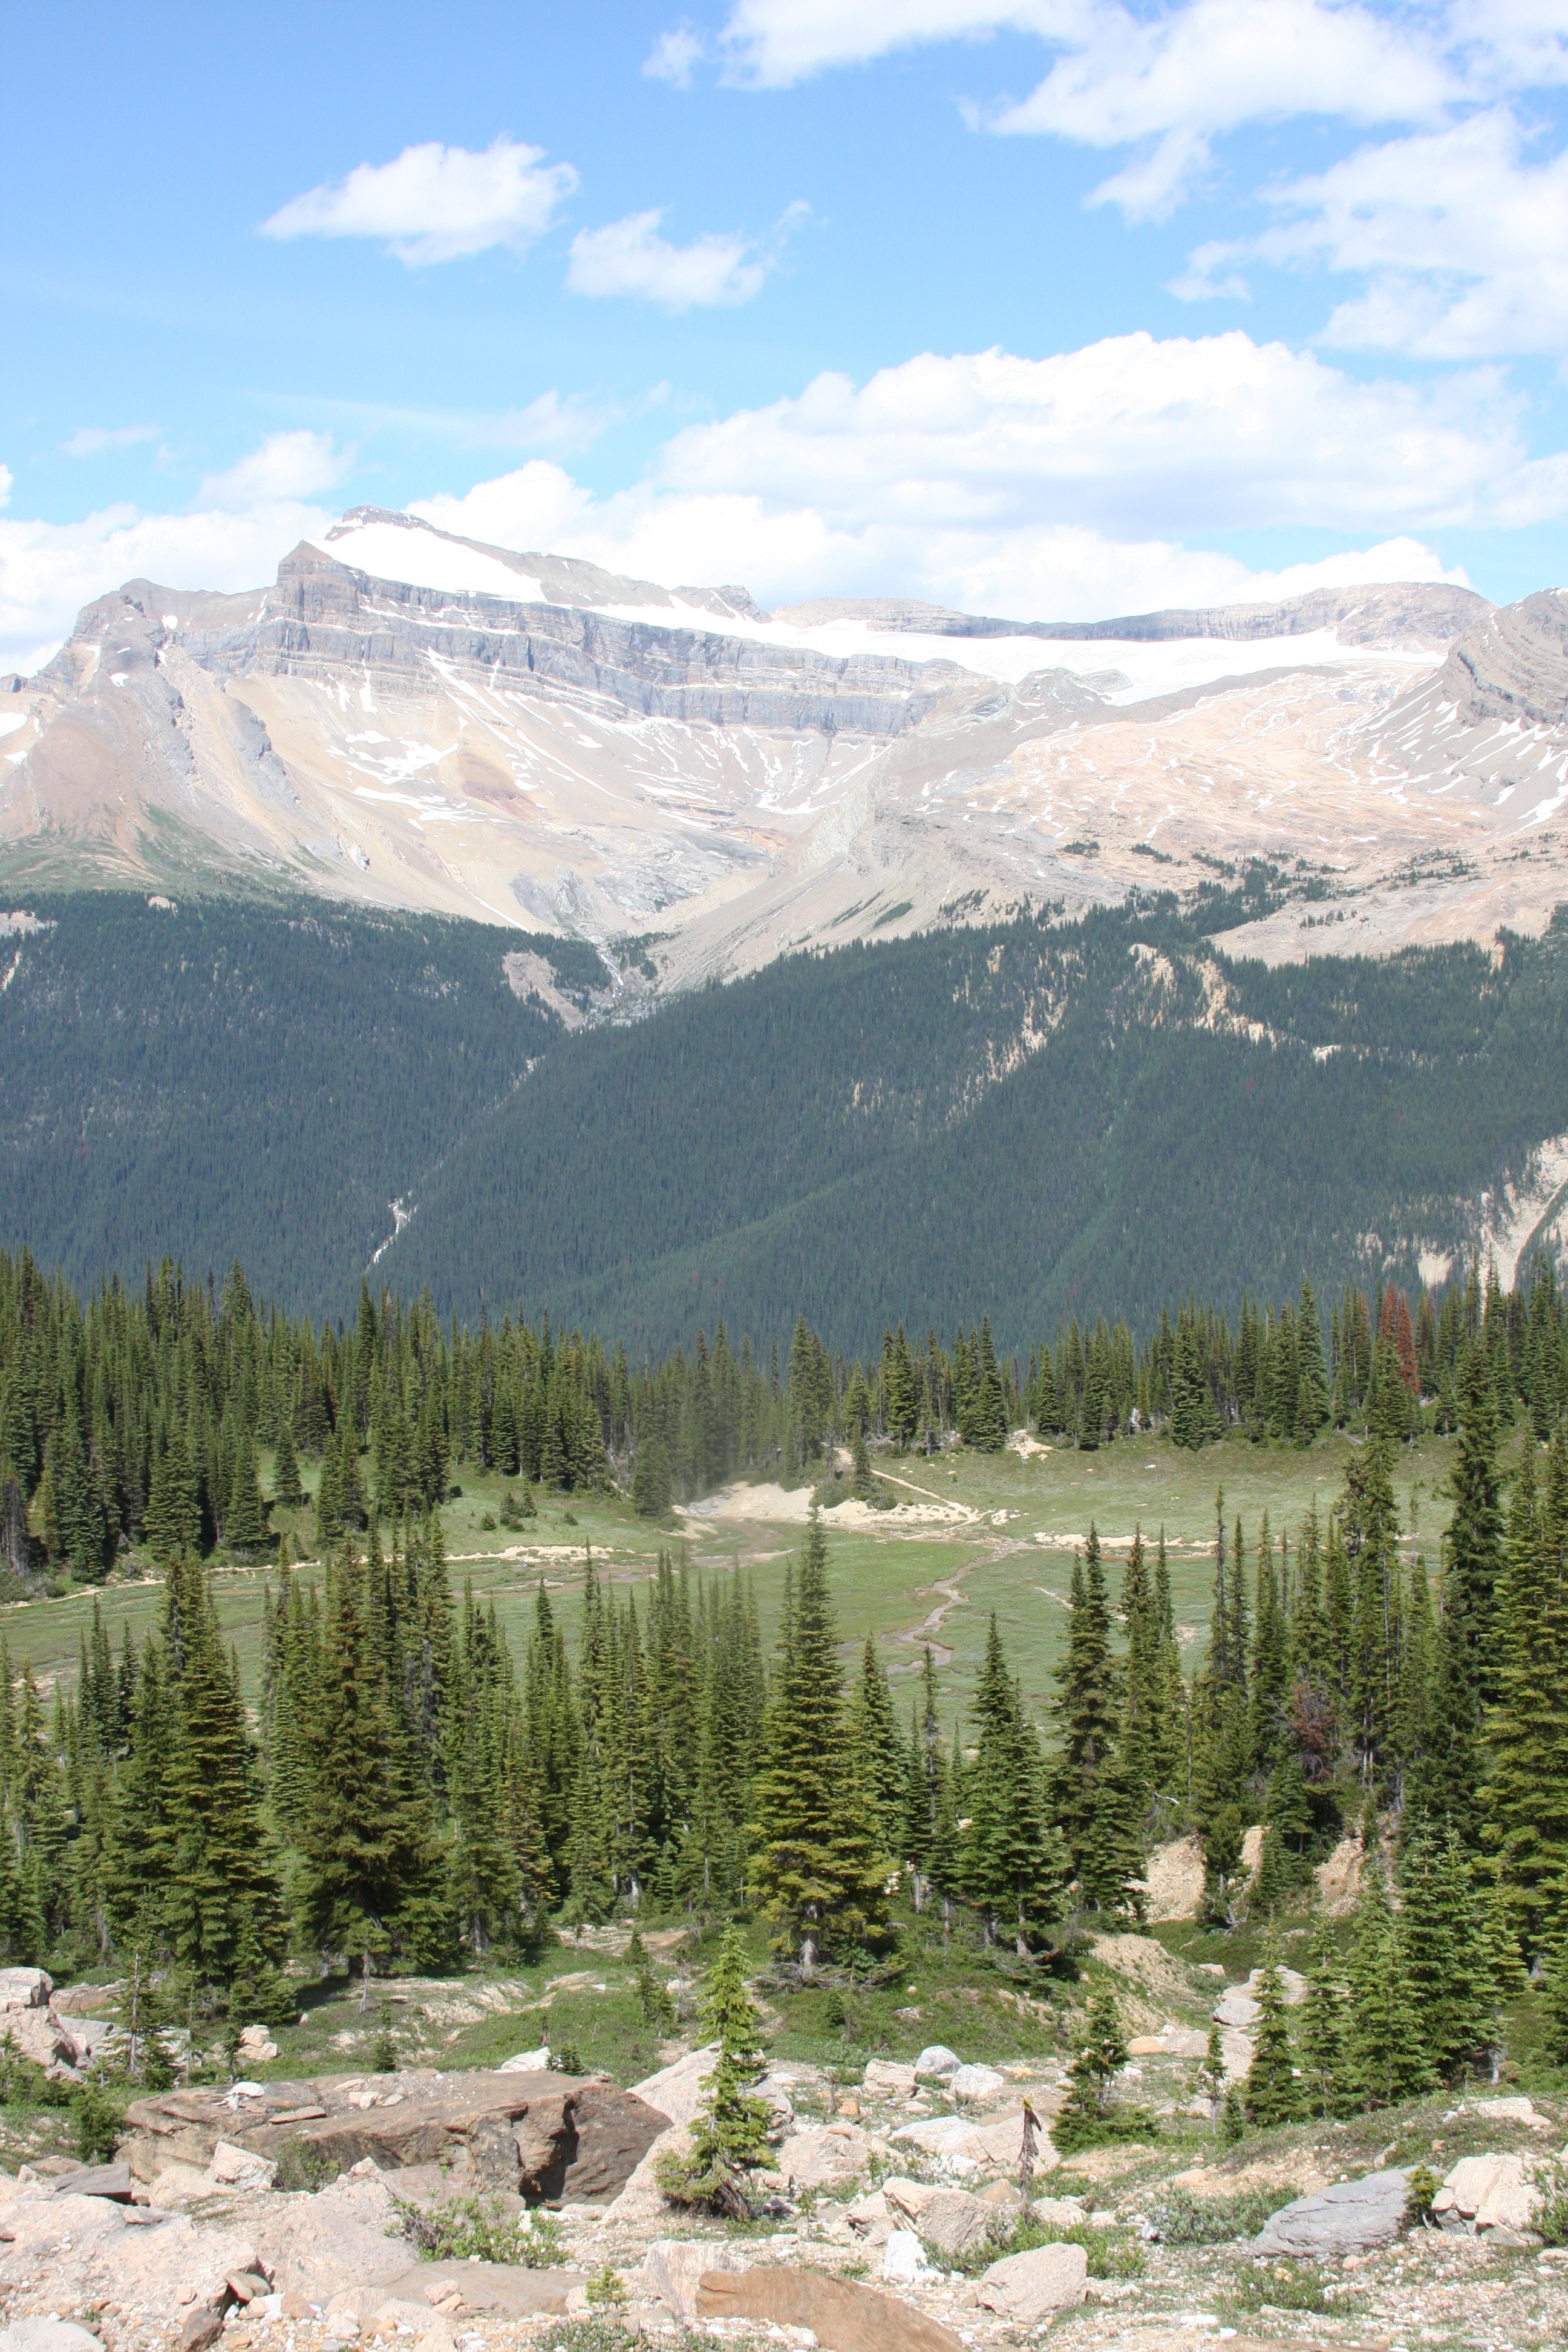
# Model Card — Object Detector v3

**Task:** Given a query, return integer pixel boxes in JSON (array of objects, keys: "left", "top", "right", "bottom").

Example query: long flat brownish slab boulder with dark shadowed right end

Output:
[{"left": 125, "top": 2072, "right": 668, "bottom": 2204}]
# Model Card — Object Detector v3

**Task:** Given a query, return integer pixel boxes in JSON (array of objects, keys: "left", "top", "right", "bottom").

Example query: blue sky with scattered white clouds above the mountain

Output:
[{"left": 0, "top": 0, "right": 1568, "bottom": 668}]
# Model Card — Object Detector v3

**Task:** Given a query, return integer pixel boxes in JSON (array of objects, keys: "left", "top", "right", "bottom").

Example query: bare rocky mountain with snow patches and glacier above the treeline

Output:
[{"left": 0, "top": 511, "right": 1568, "bottom": 981}]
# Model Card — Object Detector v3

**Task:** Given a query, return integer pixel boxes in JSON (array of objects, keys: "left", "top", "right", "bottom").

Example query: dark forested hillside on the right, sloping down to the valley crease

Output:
[{"left": 390, "top": 913, "right": 1568, "bottom": 1348}]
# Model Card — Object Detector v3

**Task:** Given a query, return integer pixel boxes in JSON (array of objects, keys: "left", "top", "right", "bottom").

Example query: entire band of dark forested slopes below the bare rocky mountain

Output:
[{"left": 0, "top": 896, "right": 1568, "bottom": 1357}]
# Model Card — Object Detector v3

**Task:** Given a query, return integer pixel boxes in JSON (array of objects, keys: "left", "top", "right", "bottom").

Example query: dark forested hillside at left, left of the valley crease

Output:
[{"left": 0, "top": 893, "right": 602, "bottom": 1308}]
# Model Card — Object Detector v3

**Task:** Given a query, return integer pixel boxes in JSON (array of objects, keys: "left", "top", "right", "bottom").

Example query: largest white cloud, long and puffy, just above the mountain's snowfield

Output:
[{"left": 414, "top": 334, "right": 1568, "bottom": 619}]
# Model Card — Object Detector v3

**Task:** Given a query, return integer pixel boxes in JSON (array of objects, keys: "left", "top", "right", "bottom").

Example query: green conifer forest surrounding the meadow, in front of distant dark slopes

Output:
[{"left": 0, "top": 1251, "right": 1568, "bottom": 2145}]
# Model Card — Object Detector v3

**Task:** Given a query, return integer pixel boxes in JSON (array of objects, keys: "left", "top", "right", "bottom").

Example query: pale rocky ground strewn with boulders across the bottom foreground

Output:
[{"left": 0, "top": 1994, "right": 1568, "bottom": 2352}]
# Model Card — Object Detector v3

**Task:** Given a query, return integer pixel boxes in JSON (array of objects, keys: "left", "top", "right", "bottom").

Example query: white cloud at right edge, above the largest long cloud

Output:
[{"left": 1178, "top": 108, "right": 1568, "bottom": 360}]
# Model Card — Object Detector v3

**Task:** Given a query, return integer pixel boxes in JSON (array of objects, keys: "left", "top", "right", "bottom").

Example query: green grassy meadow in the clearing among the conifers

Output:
[{"left": 0, "top": 1437, "right": 1453, "bottom": 1759}]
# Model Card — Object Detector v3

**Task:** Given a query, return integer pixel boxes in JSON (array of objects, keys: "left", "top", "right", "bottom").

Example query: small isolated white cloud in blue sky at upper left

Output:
[{"left": 261, "top": 139, "right": 578, "bottom": 268}]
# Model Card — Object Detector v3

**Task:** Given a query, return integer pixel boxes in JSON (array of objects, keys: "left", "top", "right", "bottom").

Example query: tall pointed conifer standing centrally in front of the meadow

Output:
[{"left": 750, "top": 1505, "right": 889, "bottom": 1971}]
